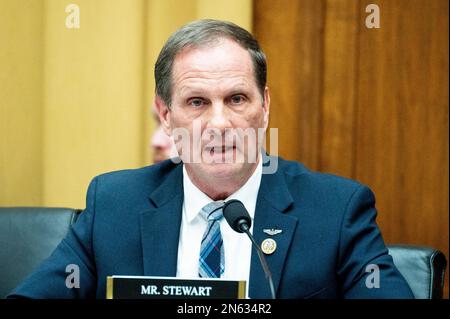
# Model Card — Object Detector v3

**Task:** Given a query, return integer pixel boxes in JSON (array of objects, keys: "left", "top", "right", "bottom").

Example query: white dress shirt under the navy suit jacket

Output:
[{"left": 177, "top": 157, "right": 262, "bottom": 295}]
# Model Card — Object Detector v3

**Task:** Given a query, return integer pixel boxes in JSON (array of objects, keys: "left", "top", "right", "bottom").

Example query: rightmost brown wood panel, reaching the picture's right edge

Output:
[{"left": 355, "top": 0, "right": 449, "bottom": 270}]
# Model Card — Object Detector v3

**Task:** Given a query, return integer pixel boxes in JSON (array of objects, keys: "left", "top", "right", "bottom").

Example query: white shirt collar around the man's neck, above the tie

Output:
[{"left": 183, "top": 157, "right": 262, "bottom": 223}]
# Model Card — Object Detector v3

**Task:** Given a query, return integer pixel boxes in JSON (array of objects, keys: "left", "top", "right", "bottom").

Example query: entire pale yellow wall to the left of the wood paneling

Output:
[{"left": 0, "top": 0, "right": 252, "bottom": 208}]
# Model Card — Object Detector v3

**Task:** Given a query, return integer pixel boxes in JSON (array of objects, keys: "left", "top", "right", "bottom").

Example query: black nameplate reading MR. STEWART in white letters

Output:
[{"left": 106, "top": 276, "right": 246, "bottom": 299}]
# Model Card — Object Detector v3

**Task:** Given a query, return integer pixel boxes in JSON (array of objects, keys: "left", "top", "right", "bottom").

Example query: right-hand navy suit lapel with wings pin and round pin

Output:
[{"left": 249, "top": 162, "right": 298, "bottom": 299}]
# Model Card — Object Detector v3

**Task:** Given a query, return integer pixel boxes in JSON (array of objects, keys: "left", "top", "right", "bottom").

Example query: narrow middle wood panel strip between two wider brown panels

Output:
[{"left": 319, "top": 0, "right": 360, "bottom": 177}]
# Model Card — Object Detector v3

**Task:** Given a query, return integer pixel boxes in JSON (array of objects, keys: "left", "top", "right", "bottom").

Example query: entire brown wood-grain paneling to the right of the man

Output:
[{"left": 254, "top": 0, "right": 449, "bottom": 297}]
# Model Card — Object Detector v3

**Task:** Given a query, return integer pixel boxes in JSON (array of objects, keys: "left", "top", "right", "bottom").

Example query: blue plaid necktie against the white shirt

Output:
[{"left": 198, "top": 201, "right": 225, "bottom": 278}]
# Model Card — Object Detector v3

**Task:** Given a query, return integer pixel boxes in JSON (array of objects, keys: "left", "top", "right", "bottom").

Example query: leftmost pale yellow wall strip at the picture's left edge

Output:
[{"left": 0, "top": 0, "right": 44, "bottom": 206}]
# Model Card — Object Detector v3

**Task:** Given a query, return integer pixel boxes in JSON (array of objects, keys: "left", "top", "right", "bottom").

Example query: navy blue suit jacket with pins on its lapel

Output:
[{"left": 10, "top": 158, "right": 413, "bottom": 298}]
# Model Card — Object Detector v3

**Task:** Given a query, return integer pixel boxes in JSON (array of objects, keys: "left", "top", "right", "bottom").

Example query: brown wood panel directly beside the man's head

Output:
[{"left": 253, "top": 0, "right": 324, "bottom": 168}]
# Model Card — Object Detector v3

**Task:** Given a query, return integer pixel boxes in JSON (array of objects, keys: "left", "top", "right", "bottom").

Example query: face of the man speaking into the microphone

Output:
[{"left": 162, "top": 39, "right": 269, "bottom": 182}]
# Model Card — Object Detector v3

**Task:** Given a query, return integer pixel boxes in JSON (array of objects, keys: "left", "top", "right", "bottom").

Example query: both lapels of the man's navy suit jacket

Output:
[{"left": 141, "top": 158, "right": 298, "bottom": 299}]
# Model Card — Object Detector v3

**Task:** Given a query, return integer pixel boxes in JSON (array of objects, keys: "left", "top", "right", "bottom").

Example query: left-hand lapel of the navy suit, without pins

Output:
[{"left": 141, "top": 165, "right": 183, "bottom": 276}]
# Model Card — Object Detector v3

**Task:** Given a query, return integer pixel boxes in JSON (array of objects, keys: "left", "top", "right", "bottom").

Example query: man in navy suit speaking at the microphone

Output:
[{"left": 7, "top": 20, "right": 412, "bottom": 298}]
